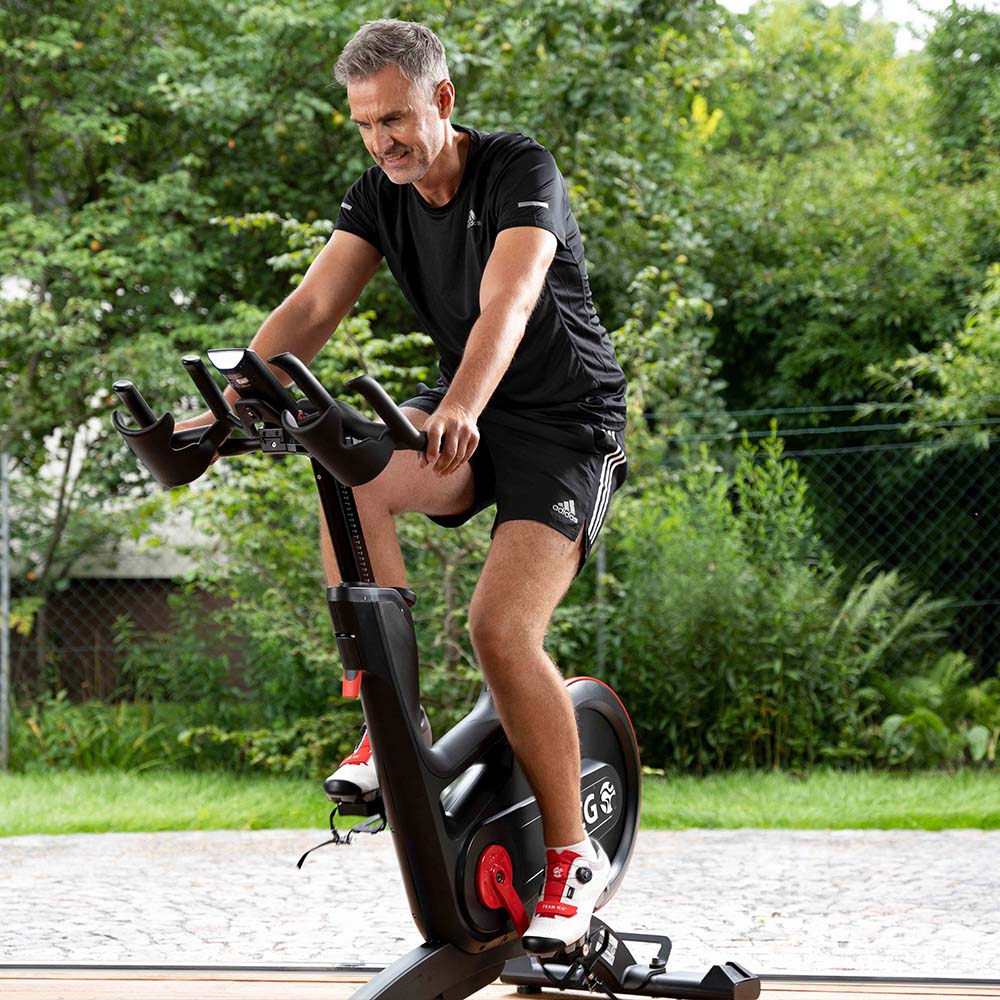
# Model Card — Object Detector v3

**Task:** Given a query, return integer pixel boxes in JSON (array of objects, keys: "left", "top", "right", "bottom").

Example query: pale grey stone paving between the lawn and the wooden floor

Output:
[{"left": 0, "top": 830, "right": 1000, "bottom": 980}]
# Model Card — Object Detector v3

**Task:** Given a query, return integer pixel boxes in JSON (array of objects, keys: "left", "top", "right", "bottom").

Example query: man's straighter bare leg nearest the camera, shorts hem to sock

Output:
[{"left": 469, "top": 521, "right": 584, "bottom": 847}]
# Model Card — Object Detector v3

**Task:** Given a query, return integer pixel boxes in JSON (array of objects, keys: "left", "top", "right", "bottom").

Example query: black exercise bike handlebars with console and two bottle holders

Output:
[{"left": 111, "top": 350, "right": 427, "bottom": 486}]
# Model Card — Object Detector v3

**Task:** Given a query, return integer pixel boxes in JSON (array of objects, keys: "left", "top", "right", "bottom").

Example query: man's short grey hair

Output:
[{"left": 333, "top": 20, "right": 449, "bottom": 96}]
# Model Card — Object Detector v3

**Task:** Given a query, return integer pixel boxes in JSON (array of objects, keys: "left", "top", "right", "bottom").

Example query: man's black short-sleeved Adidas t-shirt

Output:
[{"left": 336, "top": 126, "right": 625, "bottom": 430}]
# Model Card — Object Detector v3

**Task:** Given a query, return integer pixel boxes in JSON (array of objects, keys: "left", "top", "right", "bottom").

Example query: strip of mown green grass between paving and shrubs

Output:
[{"left": 0, "top": 771, "right": 1000, "bottom": 836}]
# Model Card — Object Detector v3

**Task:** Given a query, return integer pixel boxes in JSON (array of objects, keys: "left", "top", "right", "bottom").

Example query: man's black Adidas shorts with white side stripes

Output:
[{"left": 401, "top": 387, "right": 628, "bottom": 568}]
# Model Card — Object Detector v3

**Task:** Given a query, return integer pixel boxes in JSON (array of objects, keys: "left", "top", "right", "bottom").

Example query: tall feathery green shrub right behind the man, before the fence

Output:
[{"left": 596, "top": 436, "right": 943, "bottom": 770}]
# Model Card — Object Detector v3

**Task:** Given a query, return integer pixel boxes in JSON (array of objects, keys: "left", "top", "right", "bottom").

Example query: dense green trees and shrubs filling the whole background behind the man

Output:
[{"left": 0, "top": 0, "right": 1000, "bottom": 773}]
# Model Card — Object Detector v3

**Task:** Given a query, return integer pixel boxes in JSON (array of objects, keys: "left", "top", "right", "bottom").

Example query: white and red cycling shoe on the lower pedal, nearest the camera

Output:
[{"left": 521, "top": 840, "right": 611, "bottom": 958}]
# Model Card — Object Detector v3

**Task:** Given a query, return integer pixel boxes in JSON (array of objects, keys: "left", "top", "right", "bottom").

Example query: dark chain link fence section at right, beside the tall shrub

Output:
[{"left": 672, "top": 405, "right": 1000, "bottom": 671}]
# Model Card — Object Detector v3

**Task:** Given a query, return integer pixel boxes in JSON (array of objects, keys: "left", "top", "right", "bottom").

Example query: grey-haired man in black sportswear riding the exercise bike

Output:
[{"left": 181, "top": 21, "right": 626, "bottom": 954}]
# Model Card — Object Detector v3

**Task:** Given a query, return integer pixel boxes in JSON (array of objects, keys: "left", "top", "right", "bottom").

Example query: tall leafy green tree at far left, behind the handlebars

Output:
[{"left": 0, "top": 0, "right": 372, "bottom": 648}]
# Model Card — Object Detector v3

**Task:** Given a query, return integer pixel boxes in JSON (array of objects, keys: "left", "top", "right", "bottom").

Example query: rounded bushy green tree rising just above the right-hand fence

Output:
[{"left": 707, "top": 140, "right": 982, "bottom": 408}]
